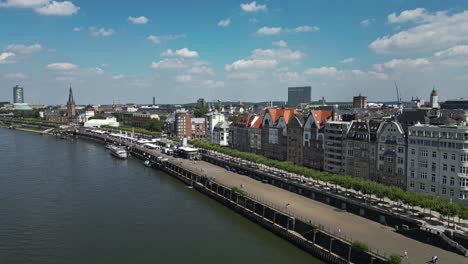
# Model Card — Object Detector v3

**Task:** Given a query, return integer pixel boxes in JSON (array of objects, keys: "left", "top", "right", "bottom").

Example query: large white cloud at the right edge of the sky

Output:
[{"left": 369, "top": 10, "right": 468, "bottom": 54}]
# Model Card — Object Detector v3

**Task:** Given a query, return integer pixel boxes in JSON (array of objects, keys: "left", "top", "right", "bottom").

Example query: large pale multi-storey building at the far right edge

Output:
[{"left": 407, "top": 124, "right": 468, "bottom": 205}]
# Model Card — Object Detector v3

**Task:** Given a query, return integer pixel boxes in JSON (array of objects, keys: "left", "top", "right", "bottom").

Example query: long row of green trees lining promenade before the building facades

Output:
[{"left": 191, "top": 140, "right": 468, "bottom": 219}]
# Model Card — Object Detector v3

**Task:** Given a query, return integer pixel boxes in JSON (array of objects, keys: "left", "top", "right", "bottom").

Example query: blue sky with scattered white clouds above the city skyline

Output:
[{"left": 0, "top": 0, "right": 468, "bottom": 104}]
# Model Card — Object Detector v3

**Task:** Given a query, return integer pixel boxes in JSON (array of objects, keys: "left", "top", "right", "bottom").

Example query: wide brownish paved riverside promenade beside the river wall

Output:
[{"left": 171, "top": 158, "right": 468, "bottom": 264}]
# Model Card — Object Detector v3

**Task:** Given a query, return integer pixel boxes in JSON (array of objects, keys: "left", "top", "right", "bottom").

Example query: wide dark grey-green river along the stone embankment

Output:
[{"left": 0, "top": 128, "right": 320, "bottom": 264}]
